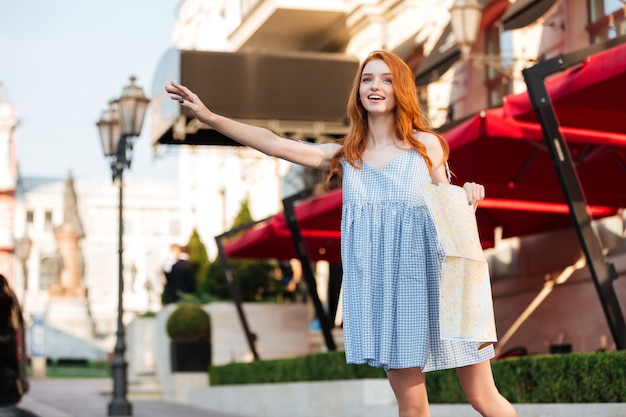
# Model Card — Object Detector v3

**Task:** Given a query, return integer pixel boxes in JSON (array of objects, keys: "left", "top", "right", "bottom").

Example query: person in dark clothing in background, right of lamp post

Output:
[{"left": 162, "top": 244, "right": 196, "bottom": 304}]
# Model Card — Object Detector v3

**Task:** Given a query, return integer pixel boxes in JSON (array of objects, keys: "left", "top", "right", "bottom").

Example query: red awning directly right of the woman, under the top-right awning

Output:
[{"left": 443, "top": 109, "right": 626, "bottom": 248}]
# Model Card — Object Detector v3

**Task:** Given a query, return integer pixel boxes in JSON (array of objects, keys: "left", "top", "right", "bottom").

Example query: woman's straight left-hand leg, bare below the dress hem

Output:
[{"left": 387, "top": 368, "right": 430, "bottom": 417}]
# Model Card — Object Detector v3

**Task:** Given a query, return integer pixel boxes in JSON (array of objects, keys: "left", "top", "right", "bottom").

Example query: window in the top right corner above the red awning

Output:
[{"left": 587, "top": 0, "right": 626, "bottom": 43}]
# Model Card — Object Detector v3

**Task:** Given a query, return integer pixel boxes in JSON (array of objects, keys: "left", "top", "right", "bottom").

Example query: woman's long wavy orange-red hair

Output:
[{"left": 326, "top": 51, "right": 450, "bottom": 188}]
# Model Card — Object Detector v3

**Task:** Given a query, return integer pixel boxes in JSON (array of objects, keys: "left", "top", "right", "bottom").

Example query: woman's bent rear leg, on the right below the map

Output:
[{"left": 456, "top": 360, "right": 517, "bottom": 417}]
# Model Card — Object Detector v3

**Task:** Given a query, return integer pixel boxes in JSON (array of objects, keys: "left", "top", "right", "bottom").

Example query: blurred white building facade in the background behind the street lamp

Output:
[{"left": 14, "top": 178, "right": 180, "bottom": 340}]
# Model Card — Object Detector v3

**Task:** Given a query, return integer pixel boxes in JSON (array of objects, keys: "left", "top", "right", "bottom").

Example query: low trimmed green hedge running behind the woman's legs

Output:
[{"left": 210, "top": 351, "right": 626, "bottom": 404}]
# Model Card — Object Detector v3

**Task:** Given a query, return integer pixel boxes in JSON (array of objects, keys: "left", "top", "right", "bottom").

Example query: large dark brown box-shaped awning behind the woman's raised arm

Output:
[{"left": 150, "top": 50, "right": 359, "bottom": 145}]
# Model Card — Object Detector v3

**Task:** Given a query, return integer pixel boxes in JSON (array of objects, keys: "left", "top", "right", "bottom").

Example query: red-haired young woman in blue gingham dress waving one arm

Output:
[{"left": 165, "top": 51, "right": 517, "bottom": 417}]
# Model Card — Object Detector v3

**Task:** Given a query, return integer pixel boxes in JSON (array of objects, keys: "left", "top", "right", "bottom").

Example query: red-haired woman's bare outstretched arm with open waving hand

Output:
[{"left": 165, "top": 82, "right": 339, "bottom": 170}]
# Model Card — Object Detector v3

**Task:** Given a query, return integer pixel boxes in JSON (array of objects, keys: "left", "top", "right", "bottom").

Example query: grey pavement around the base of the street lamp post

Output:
[{"left": 18, "top": 378, "right": 242, "bottom": 417}]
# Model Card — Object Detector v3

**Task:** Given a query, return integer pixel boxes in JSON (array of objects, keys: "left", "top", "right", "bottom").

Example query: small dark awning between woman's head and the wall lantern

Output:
[{"left": 415, "top": 24, "right": 461, "bottom": 86}]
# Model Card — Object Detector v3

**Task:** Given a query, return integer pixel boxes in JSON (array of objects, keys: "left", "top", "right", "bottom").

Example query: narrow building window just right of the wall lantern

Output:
[{"left": 485, "top": 25, "right": 513, "bottom": 107}]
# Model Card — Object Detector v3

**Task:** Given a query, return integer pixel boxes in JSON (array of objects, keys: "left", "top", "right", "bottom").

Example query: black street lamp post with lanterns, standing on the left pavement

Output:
[{"left": 97, "top": 77, "right": 149, "bottom": 416}]
